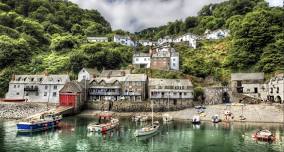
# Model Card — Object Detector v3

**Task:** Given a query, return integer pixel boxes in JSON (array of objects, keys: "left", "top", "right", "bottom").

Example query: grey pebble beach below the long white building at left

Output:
[{"left": 0, "top": 102, "right": 55, "bottom": 119}]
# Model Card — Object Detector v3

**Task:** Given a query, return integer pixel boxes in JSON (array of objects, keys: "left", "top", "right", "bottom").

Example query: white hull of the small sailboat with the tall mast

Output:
[{"left": 134, "top": 121, "right": 160, "bottom": 137}]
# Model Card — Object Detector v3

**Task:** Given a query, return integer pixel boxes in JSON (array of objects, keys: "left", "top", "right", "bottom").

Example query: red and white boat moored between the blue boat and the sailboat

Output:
[{"left": 87, "top": 118, "right": 119, "bottom": 132}]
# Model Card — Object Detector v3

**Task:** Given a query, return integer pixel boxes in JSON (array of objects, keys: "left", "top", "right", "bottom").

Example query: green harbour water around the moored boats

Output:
[{"left": 0, "top": 116, "right": 284, "bottom": 152}]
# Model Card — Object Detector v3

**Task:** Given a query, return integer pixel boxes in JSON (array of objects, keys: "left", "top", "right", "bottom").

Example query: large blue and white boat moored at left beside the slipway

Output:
[{"left": 17, "top": 113, "right": 62, "bottom": 132}]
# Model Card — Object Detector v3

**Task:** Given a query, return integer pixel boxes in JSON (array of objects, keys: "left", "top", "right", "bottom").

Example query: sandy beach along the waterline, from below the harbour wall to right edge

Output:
[{"left": 80, "top": 104, "right": 284, "bottom": 123}]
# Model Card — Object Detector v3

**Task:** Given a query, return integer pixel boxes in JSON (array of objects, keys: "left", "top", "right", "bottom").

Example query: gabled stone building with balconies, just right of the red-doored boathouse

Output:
[{"left": 89, "top": 70, "right": 147, "bottom": 101}]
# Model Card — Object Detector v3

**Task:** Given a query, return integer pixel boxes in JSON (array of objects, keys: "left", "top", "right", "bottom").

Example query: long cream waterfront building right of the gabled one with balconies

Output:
[{"left": 148, "top": 78, "right": 193, "bottom": 105}]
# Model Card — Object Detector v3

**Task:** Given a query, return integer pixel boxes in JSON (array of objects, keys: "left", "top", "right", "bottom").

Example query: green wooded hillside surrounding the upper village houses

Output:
[{"left": 0, "top": 0, "right": 284, "bottom": 96}]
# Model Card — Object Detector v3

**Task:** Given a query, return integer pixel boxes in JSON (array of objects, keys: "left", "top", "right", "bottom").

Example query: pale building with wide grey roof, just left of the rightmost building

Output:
[{"left": 231, "top": 73, "right": 267, "bottom": 100}]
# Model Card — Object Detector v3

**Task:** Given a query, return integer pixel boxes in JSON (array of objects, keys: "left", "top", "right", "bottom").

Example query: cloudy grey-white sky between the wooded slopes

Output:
[{"left": 70, "top": 0, "right": 224, "bottom": 32}]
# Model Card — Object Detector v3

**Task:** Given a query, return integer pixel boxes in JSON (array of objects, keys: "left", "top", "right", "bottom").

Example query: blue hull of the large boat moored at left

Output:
[{"left": 17, "top": 119, "right": 61, "bottom": 132}]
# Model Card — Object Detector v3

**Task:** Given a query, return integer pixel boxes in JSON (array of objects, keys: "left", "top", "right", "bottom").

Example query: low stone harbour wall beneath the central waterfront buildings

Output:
[{"left": 87, "top": 101, "right": 193, "bottom": 112}]
